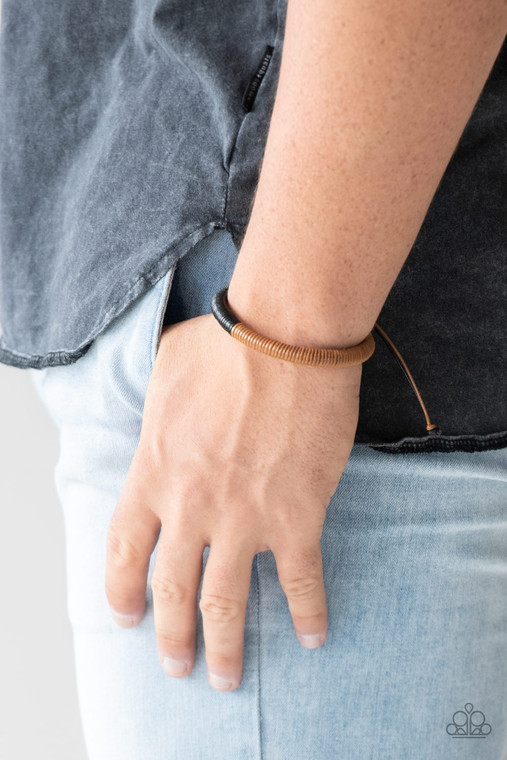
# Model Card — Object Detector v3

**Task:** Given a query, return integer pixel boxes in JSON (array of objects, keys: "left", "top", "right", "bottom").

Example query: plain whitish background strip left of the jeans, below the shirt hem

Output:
[{"left": 0, "top": 364, "right": 87, "bottom": 760}]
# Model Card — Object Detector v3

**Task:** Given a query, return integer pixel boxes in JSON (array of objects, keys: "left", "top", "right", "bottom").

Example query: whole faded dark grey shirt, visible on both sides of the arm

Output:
[{"left": 0, "top": 0, "right": 507, "bottom": 452}]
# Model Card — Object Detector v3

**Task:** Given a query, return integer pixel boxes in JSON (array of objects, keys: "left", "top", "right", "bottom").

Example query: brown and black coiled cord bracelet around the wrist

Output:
[{"left": 211, "top": 286, "right": 375, "bottom": 367}]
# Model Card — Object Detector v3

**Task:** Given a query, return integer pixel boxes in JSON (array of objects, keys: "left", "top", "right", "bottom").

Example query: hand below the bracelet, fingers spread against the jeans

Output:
[{"left": 106, "top": 314, "right": 362, "bottom": 691}]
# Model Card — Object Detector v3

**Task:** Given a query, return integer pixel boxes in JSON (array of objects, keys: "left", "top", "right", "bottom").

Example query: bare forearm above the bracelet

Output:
[{"left": 229, "top": 0, "right": 507, "bottom": 347}]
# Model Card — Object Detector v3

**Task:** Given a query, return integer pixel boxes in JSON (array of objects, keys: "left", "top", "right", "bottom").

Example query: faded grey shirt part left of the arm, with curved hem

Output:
[{"left": 0, "top": 0, "right": 286, "bottom": 360}]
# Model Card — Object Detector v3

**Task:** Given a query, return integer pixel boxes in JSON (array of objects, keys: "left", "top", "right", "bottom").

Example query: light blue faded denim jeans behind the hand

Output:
[{"left": 29, "top": 231, "right": 507, "bottom": 760}]
